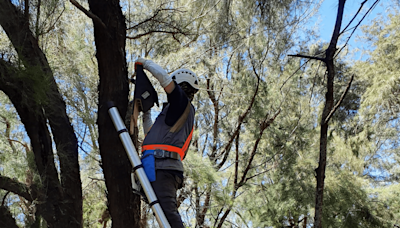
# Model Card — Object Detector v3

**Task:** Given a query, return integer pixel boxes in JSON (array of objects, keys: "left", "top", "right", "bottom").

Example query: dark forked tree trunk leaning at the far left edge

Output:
[{"left": 0, "top": 0, "right": 82, "bottom": 227}]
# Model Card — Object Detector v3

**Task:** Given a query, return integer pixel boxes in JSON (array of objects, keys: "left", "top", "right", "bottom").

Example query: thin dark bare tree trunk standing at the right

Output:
[{"left": 314, "top": 0, "right": 346, "bottom": 228}]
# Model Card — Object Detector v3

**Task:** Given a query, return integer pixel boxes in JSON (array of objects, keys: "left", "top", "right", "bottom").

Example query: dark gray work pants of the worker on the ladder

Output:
[{"left": 151, "top": 169, "right": 184, "bottom": 228}]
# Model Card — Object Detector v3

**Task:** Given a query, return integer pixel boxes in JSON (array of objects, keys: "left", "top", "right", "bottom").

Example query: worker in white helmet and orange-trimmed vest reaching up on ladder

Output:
[{"left": 135, "top": 58, "right": 199, "bottom": 228}]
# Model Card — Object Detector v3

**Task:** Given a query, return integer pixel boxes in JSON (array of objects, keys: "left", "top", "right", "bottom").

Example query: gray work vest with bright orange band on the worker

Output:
[{"left": 142, "top": 104, "right": 195, "bottom": 172}]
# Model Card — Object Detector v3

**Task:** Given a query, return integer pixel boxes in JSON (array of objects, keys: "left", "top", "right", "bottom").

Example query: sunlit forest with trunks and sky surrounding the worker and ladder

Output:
[{"left": 0, "top": 0, "right": 400, "bottom": 228}]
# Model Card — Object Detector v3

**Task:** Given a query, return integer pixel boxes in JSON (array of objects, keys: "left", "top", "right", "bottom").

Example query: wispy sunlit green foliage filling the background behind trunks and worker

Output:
[{"left": 0, "top": 0, "right": 400, "bottom": 227}]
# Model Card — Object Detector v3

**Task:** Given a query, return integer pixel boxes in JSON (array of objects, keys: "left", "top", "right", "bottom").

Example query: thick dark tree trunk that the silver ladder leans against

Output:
[{"left": 89, "top": 0, "right": 140, "bottom": 228}]
